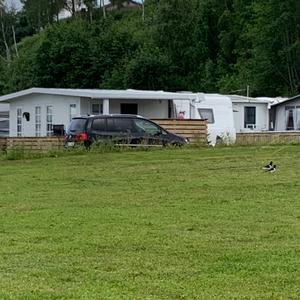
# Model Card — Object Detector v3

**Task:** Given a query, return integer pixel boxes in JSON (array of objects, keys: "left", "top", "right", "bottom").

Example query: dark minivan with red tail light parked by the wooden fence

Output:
[{"left": 66, "top": 114, "right": 188, "bottom": 147}]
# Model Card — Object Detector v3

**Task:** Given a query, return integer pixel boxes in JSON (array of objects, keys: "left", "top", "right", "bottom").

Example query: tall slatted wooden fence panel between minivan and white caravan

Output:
[{"left": 153, "top": 119, "right": 207, "bottom": 144}]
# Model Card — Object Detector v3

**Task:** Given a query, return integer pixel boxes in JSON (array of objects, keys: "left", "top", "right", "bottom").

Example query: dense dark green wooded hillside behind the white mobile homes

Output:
[{"left": 0, "top": 0, "right": 300, "bottom": 96}]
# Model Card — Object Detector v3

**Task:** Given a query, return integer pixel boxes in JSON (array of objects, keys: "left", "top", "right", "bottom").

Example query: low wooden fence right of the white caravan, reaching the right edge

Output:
[{"left": 236, "top": 131, "right": 300, "bottom": 145}]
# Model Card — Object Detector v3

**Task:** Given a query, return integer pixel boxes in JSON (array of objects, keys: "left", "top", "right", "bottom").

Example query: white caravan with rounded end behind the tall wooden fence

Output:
[{"left": 174, "top": 93, "right": 236, "bottom": 146}]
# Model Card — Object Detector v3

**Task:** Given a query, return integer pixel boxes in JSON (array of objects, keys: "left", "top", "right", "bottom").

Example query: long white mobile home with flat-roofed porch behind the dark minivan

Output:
[{"left": 0, "top": 88, "right": 196, "bottom": 137}]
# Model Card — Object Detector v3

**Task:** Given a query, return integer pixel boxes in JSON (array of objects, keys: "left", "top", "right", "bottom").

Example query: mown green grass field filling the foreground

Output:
[{"left": 0, "top": 145, "right": 300, "bottom": 300}]
